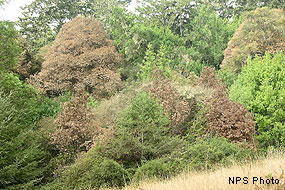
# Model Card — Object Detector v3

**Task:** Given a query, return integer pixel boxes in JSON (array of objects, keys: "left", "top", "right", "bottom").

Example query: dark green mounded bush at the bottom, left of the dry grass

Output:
[{"left": 48, "top": 146, "right": 129, "bottom": 190}]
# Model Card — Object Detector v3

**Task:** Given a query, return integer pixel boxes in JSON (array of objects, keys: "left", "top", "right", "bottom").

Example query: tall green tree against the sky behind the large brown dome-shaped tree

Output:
[{"left": 19, "top": 0, "right": 124, "bottom": 49}]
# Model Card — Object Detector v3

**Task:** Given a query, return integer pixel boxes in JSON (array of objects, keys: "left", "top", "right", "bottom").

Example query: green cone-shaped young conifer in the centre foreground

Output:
[{"left": 100, "top": 92, "right": 184, "bottom": 168}]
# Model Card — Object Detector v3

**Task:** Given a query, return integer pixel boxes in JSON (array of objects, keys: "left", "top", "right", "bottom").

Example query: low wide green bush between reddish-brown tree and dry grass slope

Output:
[{"left": 168, "top": 135, "right": 253, "bottom": 172}]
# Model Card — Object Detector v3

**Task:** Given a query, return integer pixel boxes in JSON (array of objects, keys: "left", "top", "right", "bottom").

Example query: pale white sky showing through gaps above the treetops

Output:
[{"left": 0, "top": 0, "right": 136, "bottom": 21}]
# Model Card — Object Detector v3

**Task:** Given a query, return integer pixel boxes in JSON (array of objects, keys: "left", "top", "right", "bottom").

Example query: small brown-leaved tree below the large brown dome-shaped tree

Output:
[{"left": 51, "top": 93, "right": 92, "bottom": 153}]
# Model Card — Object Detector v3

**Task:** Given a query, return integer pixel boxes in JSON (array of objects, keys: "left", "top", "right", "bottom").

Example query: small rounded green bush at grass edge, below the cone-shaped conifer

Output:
[{"left": 133, "top": 159, "right": 169, "bottom": 182}]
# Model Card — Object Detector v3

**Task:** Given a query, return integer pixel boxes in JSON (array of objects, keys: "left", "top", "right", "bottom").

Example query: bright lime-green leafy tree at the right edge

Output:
[{"left": 230, "top": 52, "right": 285, "bottom": 148}]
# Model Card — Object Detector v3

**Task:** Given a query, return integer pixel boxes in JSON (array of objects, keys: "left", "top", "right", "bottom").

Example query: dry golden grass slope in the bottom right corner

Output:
[{"left": 124, "top": 153, "right": 285, "bottom": 190}]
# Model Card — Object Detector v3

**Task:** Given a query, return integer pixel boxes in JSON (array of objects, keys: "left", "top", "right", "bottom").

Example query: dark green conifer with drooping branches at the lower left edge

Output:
[{"left": 0, "top": 72, "right": 58, "bottom": 190}]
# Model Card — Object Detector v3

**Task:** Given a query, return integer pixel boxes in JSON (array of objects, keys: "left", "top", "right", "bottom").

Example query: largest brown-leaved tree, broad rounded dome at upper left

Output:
[{"left": 31, "top": 16, "right": 122, "bottom": 99}]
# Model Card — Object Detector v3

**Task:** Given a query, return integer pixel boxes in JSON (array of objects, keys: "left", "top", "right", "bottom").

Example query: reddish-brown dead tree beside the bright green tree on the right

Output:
[{"left": 198, "top": 67, "right": 255, "bottom": 147}]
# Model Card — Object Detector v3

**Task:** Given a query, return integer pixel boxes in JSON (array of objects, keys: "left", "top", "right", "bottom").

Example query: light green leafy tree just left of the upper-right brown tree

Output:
[{"left": 185, "top": 5, "right": 240, "bottom": 68}]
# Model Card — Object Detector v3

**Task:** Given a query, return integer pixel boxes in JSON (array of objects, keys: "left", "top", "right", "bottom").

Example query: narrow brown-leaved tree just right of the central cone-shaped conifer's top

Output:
[{"left": 146, "top": 70, "right": 190, "bottom": 135}]
